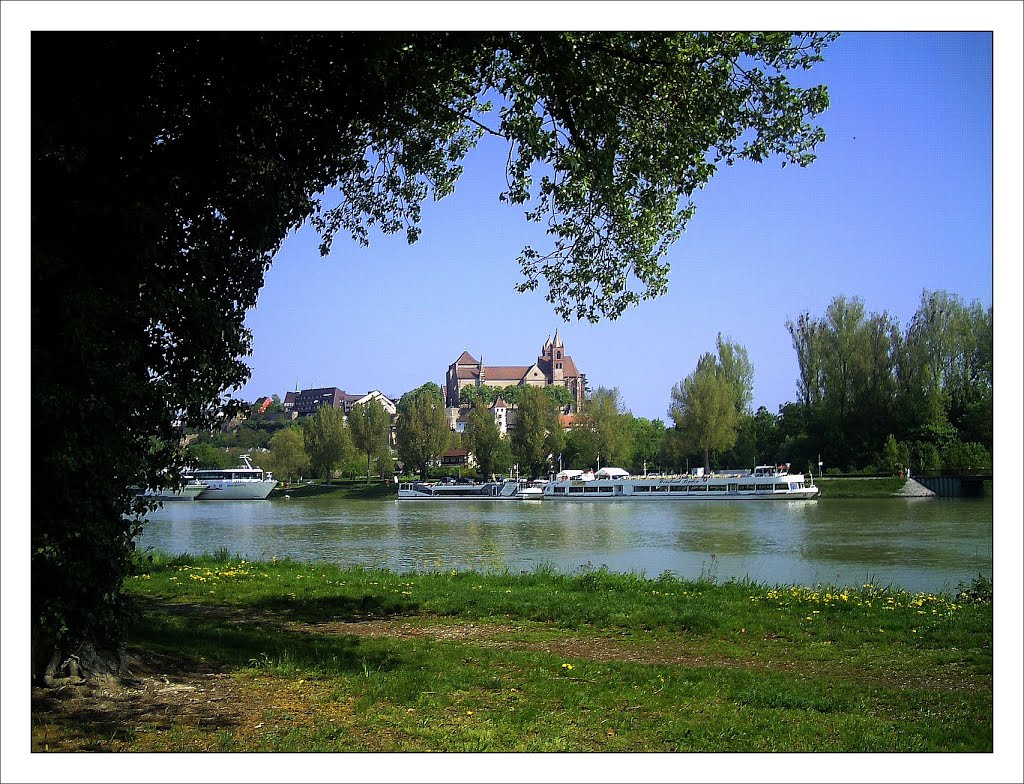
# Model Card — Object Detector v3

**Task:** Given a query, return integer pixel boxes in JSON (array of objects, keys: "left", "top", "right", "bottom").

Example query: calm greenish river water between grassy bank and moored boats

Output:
[{"left": 140, "top": 496, "right": 992, "bottom": 593}]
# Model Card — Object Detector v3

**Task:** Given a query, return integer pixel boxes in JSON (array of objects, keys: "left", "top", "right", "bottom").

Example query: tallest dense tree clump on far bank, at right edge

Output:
[{"left": 778, "top": 291, "right": 993, "bottom": 471}]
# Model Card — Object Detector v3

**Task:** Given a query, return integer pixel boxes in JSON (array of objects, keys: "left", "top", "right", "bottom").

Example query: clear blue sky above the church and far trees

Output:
[{"left": 237, "top": 32, "right": 993, "bottom": 419}]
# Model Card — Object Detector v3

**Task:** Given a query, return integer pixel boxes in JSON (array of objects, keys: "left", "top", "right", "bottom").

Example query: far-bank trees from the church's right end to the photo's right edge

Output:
[{"left": 564, "top": 291, "right": 993, "bottom": 473}]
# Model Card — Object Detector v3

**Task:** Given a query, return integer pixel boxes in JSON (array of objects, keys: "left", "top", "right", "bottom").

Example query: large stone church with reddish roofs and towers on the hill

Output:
[{"left": 444, "top": 330, "right": 587, "bottom": 411}]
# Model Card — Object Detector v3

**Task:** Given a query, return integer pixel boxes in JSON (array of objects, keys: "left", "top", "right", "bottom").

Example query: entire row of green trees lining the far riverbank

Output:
[{"left": 195, "top": 292, "right": 992, "bottom": 479}]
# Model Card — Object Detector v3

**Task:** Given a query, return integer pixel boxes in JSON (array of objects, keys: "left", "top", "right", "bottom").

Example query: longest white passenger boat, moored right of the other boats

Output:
[{"left": 544, "top": 465, "right": 820, "bottom": 500}]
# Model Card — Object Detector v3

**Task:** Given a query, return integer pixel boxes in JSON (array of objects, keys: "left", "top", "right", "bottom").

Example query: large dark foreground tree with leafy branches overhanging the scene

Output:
[{"left": 32, "top": 32, "right": 833, "bottom": 677}]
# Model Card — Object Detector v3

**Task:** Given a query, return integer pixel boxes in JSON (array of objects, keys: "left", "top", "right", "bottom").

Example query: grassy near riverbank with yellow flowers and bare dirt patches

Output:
[{"left": 32, "top": 553, "right": 992, "bottom": 751}]
